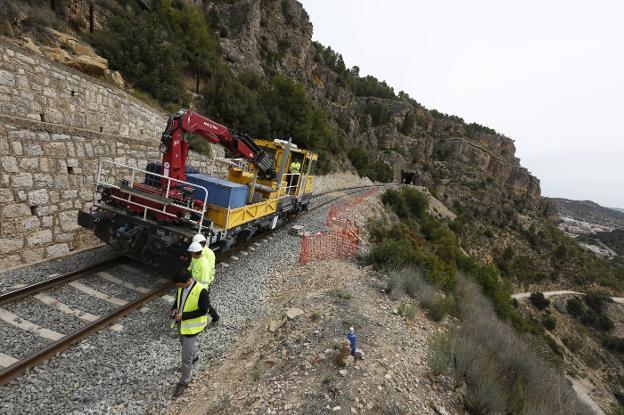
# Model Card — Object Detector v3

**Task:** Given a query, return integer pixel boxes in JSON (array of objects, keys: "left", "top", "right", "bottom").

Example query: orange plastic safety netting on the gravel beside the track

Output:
[{"left": 299, "top": 189, "right": 377, "bottom": 263}]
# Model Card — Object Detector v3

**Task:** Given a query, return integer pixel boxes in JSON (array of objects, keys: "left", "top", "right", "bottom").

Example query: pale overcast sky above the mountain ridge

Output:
[{"left": 300, "top": 0, "right": 624, "bottom": 207}]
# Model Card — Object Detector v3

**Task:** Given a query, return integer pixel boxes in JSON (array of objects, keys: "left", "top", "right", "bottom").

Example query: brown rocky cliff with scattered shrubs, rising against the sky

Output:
[{"left": 206, "top": 0, "right": 554, "bottom": 216}]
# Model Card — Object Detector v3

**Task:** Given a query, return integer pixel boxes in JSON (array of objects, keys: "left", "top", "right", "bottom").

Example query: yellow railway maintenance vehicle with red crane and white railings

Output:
[{"left": 78, "top": 110, "right": 318, "bottom": 270}]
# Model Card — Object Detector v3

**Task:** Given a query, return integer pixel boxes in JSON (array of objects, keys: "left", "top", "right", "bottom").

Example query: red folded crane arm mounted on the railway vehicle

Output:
[{"left": 160, "top": 110, "right": 272, "bottom": 183}]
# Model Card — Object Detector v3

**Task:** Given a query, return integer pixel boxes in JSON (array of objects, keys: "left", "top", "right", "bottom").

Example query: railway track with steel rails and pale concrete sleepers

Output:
[{"left": 0, "top": 185, "right": 383, "bottom": 386}]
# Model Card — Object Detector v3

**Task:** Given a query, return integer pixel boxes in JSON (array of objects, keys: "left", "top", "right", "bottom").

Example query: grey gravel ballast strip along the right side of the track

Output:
[{"left": 0, "top": 189, "right": 372, "bottom": 414}]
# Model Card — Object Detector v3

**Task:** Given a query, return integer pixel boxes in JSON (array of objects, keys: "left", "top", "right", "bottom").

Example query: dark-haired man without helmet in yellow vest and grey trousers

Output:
[{"left": 170, "top": 271, "right": 212, "bottom": 396}]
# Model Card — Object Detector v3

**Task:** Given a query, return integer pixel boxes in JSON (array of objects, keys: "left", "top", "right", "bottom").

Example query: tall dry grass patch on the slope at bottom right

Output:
[{"left": 429, "top": 278, "right": 588, "bottom": 415}]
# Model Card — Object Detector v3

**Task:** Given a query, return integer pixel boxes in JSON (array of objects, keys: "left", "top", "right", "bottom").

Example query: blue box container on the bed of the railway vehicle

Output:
[{"left": 186, "top": 174, "right": 247, "bottom": 209}]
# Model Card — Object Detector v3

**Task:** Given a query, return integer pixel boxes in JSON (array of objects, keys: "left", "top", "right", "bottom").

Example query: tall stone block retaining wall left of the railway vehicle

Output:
[{"left": 0, "top": 43, "right": 223, "bottom": 270}]
